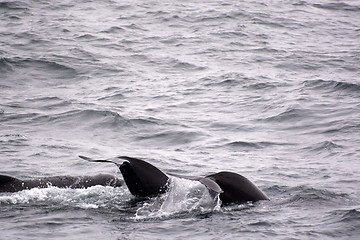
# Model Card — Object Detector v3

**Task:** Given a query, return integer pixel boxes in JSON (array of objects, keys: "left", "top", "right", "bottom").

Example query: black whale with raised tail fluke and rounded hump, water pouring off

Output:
[{"left": 79, "top": 156, "right": 269, "bottom": 204}]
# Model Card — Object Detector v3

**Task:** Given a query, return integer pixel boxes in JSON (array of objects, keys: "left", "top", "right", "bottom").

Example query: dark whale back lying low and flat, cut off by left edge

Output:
[{"left": 0, "top": 174, "right": 123, "bottom": 192}]
